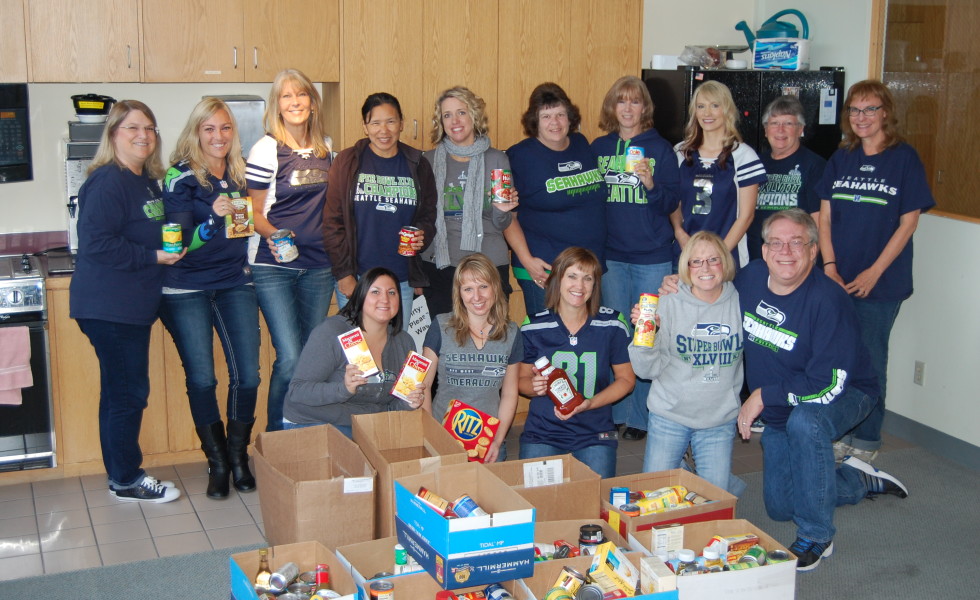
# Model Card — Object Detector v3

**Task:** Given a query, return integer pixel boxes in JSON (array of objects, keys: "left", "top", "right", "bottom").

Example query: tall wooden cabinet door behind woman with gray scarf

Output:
[{"left": 419, "top": 0, "right": 500, "bottom": 150}]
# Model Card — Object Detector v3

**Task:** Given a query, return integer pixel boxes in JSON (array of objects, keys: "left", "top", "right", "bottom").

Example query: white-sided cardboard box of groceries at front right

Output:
[{"left": 630, "top": 519, "right": 796, "bottom": 600}]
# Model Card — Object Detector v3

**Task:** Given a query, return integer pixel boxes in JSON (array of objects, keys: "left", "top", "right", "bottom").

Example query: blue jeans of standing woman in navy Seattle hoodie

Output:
[{"left": 602, "top": 260, "right": 671, "bottom": 431}]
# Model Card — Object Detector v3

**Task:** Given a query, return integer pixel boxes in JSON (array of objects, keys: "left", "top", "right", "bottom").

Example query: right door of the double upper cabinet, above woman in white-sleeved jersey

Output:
[{"left": 245, "top": 0, "right": 340, "bottom": 82}]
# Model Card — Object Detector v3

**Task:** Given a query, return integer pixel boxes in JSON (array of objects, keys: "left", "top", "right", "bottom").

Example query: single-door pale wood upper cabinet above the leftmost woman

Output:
[{"left": 28, "top": 0, "right": 140, "bottom": 83}]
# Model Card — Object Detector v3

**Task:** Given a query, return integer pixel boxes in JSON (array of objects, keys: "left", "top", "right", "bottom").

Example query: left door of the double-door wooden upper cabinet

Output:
[{"left": 143, "top": 0, "right": 245, "bottom": 82}]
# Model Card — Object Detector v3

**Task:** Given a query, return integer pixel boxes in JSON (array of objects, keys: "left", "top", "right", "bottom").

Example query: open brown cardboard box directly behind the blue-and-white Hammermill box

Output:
[{"left": 352, "top": 410, "right": 467, "bottom": 539}]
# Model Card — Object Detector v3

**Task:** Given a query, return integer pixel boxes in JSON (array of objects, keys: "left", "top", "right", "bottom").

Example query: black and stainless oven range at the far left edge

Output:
[{"left": 0, "top": 255, "right": 55, "bottom": 472}]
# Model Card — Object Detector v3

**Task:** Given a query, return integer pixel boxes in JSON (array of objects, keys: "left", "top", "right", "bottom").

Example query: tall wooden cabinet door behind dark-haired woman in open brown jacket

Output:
[{"left": 335, "top": 0, "right": 426, "bottom": 150}]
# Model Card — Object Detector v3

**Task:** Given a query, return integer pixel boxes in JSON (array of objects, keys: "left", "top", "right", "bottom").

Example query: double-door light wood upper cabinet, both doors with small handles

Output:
[{"left": 143, "top": 0, "right": 340, "bottom": 82}]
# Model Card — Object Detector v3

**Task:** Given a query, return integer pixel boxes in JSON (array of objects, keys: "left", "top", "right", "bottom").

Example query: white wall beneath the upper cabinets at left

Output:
[{"left": 0, "top": 83, "right": 269, "bottom": 233}]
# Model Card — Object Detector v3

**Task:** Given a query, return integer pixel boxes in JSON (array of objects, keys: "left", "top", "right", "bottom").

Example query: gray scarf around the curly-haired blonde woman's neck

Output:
[{"left": 432, "top": 135, "right": 490, "bottom": 269}]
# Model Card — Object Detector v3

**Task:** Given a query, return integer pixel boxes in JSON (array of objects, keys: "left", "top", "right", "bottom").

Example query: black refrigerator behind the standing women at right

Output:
[{"left": 643, "top": 67, "right": 844, "bottom": 158}]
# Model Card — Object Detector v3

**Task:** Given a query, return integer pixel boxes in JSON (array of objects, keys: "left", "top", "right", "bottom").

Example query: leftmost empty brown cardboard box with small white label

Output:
[{"left": 255, "top": 425, "right": 376, "bottom": 548}]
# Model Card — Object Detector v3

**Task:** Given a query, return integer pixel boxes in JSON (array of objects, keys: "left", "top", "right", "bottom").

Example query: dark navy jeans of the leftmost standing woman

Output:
[{"left": 78, "top": 319, "right": 151, "bottom": 489}]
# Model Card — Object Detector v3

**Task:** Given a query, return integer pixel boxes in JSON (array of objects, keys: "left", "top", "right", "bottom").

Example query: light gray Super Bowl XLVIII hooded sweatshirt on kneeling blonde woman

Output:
[{"left": 629, "top": 282, "right": 742, "bottom": 426}]
